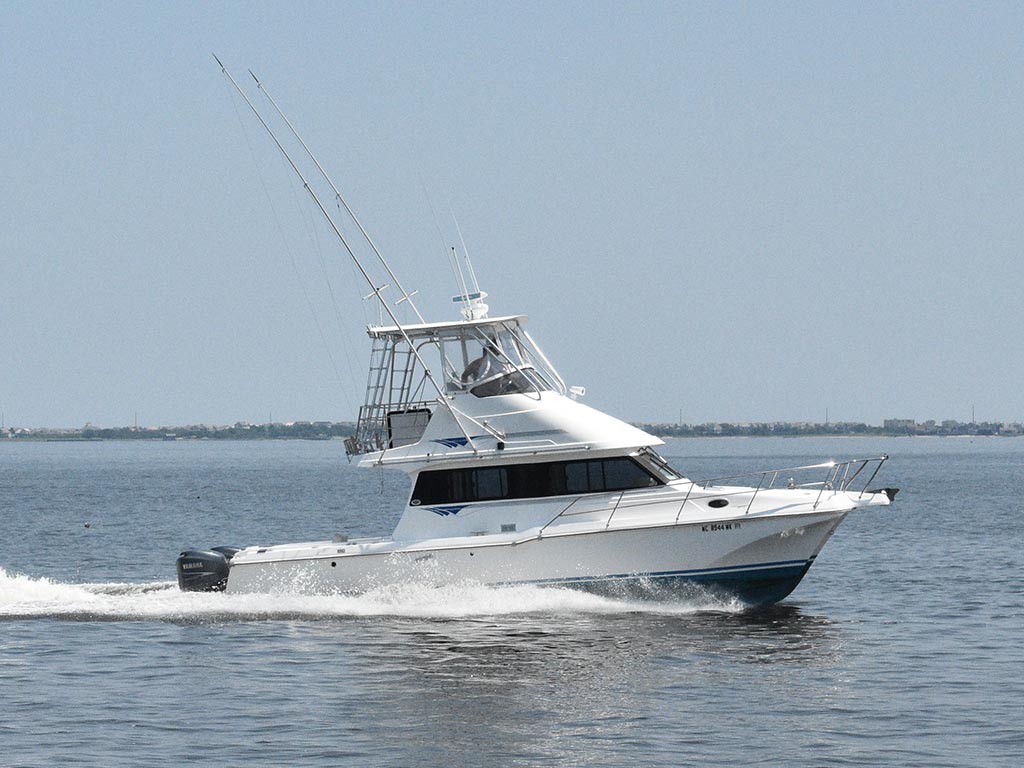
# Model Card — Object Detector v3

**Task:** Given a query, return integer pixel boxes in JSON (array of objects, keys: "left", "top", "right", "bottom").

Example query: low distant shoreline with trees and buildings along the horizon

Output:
[{"left": 0, "top": 419, "right": 1024, "bottom": 442}]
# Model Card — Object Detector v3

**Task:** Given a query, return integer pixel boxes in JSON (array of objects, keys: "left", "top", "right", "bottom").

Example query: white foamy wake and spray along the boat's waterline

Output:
[{"left": 0, "top": 567, "right": 742, "bottom": 622}]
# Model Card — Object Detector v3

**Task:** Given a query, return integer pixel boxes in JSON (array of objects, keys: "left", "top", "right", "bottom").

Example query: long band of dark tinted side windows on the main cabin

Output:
[{"left": 410, "top": 456, "right": 664, "bottom": 506}]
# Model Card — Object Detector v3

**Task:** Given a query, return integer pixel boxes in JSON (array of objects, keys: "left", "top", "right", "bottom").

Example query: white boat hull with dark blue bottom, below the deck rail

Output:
[{"left": 227, "top": 510, "right": 849, "bottom": 605}]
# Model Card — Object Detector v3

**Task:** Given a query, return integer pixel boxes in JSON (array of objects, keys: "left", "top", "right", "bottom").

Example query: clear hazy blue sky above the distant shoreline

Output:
[{"left": 0, "top": 0, "right": 1024, "bottom": 427}]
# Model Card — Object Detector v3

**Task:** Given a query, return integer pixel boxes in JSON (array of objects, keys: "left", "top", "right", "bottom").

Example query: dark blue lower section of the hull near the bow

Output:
[{"left": 539, "top": 557, "right": 814, "bottom": 607}]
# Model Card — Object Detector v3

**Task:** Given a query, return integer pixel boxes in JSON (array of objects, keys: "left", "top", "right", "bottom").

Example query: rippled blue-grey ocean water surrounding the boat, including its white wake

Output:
[{"left": 0, "top": 438, "right": 1024, "bottom": 767}]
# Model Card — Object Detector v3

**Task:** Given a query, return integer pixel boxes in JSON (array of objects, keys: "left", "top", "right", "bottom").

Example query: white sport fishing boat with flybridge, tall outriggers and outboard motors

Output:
[{"left": 177, "top": 63, "right": 896, "bottom": 605}]
